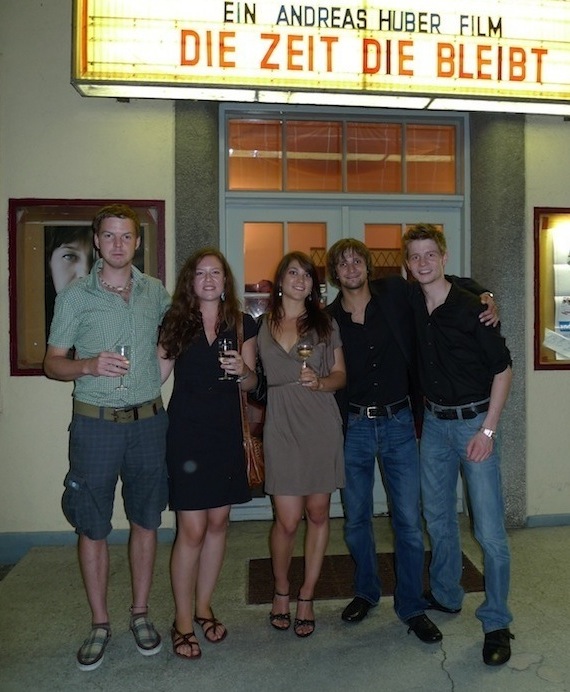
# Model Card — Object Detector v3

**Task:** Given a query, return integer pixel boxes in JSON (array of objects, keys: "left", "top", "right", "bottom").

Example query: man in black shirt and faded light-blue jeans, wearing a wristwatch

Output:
[{"left": 403, "top": 224, "right": 512, "bottom": 665}]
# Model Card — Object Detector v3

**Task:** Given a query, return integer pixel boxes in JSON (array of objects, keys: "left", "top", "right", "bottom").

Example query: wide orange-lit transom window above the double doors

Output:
[{"left": 226, "top": 115, "right": 462, "bottom": 196}]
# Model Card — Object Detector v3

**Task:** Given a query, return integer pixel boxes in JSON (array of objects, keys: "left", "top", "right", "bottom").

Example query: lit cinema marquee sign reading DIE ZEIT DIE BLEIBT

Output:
[{"left": 72, "top": 0, "right": 570, "bottom": 102}]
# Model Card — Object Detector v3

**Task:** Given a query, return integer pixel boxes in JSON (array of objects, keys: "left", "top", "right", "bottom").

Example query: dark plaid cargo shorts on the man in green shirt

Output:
[{"left": 62, "top": 409, "right": 168, "bottom": 541}]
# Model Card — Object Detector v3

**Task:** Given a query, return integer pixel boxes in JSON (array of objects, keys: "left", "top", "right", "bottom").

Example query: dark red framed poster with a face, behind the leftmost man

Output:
[{"left": 8, "top": 199, "right": 165, "bottom": 375}]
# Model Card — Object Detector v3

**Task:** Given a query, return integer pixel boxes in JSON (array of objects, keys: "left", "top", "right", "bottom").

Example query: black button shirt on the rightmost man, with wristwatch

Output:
[{"left": 413, "top": 284, "right": 512, "bottom": 406}]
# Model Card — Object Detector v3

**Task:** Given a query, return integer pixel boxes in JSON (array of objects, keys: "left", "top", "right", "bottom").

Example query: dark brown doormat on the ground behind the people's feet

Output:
[{"left": 247, "top": 551, "right": 485, "bottom": 605}]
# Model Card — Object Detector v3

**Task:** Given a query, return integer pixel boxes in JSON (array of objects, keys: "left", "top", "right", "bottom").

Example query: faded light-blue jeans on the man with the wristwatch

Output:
[{"left": 420, "top": 410, "right": 512, "bottom": 632}]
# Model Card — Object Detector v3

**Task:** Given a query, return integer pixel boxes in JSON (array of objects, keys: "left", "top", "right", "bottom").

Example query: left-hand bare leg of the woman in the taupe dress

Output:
[{"left": 270, "top": 495, "right": 304, "bottom": 615}]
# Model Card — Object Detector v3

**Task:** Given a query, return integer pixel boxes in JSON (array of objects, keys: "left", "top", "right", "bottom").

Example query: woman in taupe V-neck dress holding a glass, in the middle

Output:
[{"left": 258, "top": 252, "right": 346, "bottom": 637}]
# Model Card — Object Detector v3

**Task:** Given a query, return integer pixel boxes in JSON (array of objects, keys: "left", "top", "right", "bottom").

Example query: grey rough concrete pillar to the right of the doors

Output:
[{"left": 470, "top": 113, "right": 532, "bottom": 526}]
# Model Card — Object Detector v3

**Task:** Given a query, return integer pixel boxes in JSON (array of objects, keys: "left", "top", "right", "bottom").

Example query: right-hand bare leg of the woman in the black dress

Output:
[{"left": 195, "top": 505, "right": 230, "bottom": 641}]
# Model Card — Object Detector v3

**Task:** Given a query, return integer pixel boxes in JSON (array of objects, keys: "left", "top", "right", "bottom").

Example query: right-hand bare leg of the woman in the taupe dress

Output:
[{"left": 296, "top": 493, "right": 330, "bottom": 634}]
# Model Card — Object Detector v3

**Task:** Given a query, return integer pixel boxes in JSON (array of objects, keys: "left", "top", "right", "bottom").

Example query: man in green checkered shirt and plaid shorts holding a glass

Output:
[{"left": 44, "top": 205, "right": 170, "bottom": 670}]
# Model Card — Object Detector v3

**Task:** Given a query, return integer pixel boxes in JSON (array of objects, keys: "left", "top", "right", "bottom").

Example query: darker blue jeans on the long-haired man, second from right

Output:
[{"left": 342, "top": 408, "right": 426, "bottom": 621}]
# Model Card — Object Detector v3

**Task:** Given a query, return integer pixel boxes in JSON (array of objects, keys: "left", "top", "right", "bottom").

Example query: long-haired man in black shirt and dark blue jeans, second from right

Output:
[{"left": 326, "top": 238, "right": 493, "bottom": 642}]
